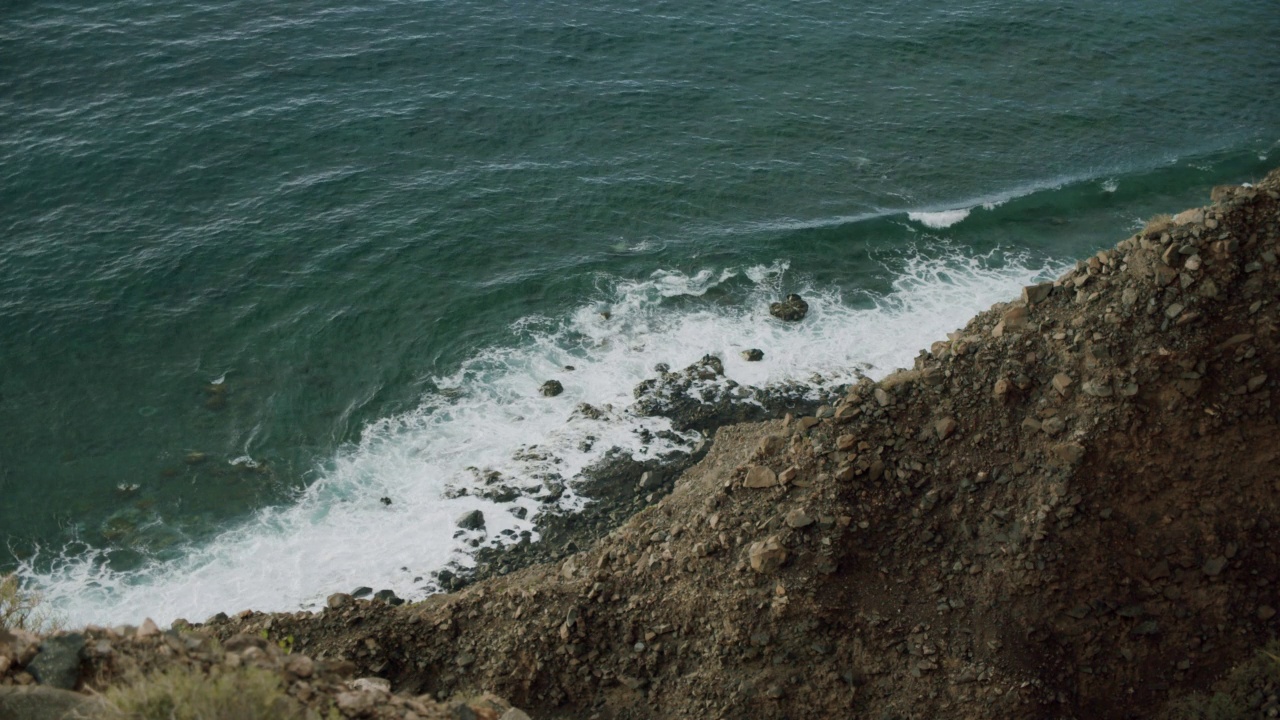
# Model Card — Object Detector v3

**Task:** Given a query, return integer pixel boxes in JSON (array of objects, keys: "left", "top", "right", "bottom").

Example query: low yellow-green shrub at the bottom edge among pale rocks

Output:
[{"left": 97, "top": 667, "right": 303, "bottom": 720}]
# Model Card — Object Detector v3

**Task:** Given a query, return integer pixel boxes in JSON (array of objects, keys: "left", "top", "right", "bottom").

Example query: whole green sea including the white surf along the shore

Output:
[{"left": 0, "top": 0, "right": 1280, "bottom": 621}]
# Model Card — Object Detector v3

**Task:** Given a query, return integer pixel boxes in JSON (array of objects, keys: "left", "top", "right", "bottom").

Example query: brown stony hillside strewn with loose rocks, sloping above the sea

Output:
[{"left": 0, "top": 172, "right": 1280, "bottom": 720}]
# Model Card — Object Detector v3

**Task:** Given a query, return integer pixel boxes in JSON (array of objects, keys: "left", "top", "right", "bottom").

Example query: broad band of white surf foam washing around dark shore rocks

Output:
[{"left": 23, "top": 244, "right": 1062, "bottom": 625}]
